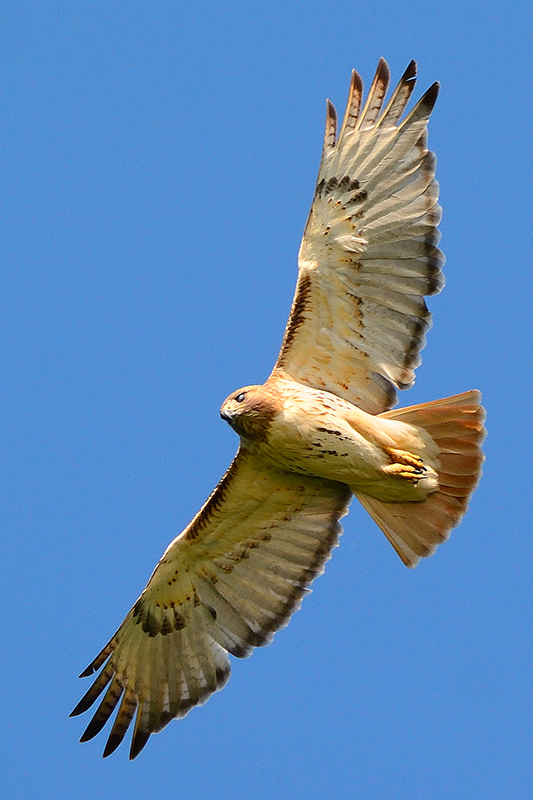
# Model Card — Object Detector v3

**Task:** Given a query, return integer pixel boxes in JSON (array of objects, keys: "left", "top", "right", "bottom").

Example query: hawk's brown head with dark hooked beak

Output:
[{"left": 220, "top": 385, "right": 278, "bottom": 440}]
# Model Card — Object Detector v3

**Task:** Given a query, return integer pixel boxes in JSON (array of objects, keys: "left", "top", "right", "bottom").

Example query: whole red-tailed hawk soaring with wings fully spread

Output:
[{"left": 72, "top": 59, "right": 485, "bottom": 758}]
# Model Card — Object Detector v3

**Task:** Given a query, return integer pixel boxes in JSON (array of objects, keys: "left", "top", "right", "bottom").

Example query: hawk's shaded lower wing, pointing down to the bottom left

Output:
[{"left": 72, "top": 451, "right": 351, "bottom": 758}]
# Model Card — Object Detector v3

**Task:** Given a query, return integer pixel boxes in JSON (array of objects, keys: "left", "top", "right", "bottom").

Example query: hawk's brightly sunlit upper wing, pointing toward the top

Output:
[{"left": 274, "top": 59, "right": 444, "bottom": 414}]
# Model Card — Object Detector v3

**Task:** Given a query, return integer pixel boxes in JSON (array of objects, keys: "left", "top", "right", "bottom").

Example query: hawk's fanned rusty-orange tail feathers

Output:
[{"left": 356, "top": 389, "right": 486, "bottom": 567}]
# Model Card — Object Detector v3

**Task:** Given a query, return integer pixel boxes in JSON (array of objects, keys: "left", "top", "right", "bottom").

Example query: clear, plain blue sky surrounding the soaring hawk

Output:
[{"left": 0, "top": 0, "right": 533, "bottom": 800}]
